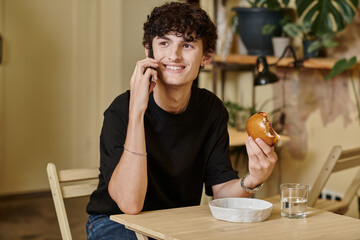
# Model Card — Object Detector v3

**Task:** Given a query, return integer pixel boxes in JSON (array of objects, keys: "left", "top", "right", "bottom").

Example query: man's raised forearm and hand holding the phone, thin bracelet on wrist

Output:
[{"left": 108, "top": 58, "right": 159, "bottom": 214}]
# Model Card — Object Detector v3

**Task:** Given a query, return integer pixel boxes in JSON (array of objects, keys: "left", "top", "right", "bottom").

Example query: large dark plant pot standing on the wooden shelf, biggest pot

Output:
[{"left": 232, "top": 7, "right": 284, "bottom": 55}]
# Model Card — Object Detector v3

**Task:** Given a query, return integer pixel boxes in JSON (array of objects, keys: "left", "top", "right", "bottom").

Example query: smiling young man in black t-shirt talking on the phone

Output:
[{"left": 87, "top": 3, "right": 277, "bottom": 239}]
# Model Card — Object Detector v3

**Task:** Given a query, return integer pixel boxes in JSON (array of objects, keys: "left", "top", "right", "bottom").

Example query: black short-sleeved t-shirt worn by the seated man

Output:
[{"left": 86, "top": 87, "right": 238, "bottom": 215}]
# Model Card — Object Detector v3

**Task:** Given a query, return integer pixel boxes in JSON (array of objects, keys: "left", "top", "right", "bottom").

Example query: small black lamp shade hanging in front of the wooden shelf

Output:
[{"left": 254, "top": 56, "right": 279, "bottom": 86}]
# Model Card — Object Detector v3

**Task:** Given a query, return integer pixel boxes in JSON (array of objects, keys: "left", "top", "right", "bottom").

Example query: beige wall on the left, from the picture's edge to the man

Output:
[{"left": 0, "top": 0, "right": 164, "bottom": 194}]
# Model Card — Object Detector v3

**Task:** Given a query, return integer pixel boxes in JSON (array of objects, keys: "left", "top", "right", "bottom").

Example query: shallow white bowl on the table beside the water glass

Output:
[{"left": 209, "top": 198, "right": 273, "bottom": 222}]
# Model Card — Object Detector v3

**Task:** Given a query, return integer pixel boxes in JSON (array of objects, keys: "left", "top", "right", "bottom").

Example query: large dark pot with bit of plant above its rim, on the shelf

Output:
[{"left": 232, "top": 0, "right": 289, "bottom": 55}]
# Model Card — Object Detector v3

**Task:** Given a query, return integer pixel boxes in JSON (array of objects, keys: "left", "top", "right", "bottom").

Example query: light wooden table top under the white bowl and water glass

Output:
[{"left": 110, "top": 195, "right": 360, "bottom": 240}]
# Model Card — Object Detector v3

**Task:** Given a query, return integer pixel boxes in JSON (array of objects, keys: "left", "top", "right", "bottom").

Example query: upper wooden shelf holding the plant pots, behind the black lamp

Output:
[{"left": 214, "top": 54, "right": 360, "bottom": 70}]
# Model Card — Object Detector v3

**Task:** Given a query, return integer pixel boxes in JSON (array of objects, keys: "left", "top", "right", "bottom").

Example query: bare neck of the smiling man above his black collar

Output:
[{"left": 154, "top": 84, "right": 192, "bottom": 114}]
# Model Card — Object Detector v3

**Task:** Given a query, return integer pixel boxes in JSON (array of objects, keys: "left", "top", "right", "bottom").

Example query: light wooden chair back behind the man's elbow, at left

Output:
[{"left": 47, "top": 163, "right": 99, "bottom": 240}]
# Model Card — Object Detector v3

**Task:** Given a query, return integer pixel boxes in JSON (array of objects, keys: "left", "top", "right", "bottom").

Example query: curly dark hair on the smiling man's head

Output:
[{"left": 143, "top": 2, "right": 217, "bottom": 53}]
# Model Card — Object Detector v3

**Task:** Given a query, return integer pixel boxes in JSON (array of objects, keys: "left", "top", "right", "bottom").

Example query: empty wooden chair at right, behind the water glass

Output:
[{"left": 308, "top": 146, "right": 360, "bottom": 214}]
